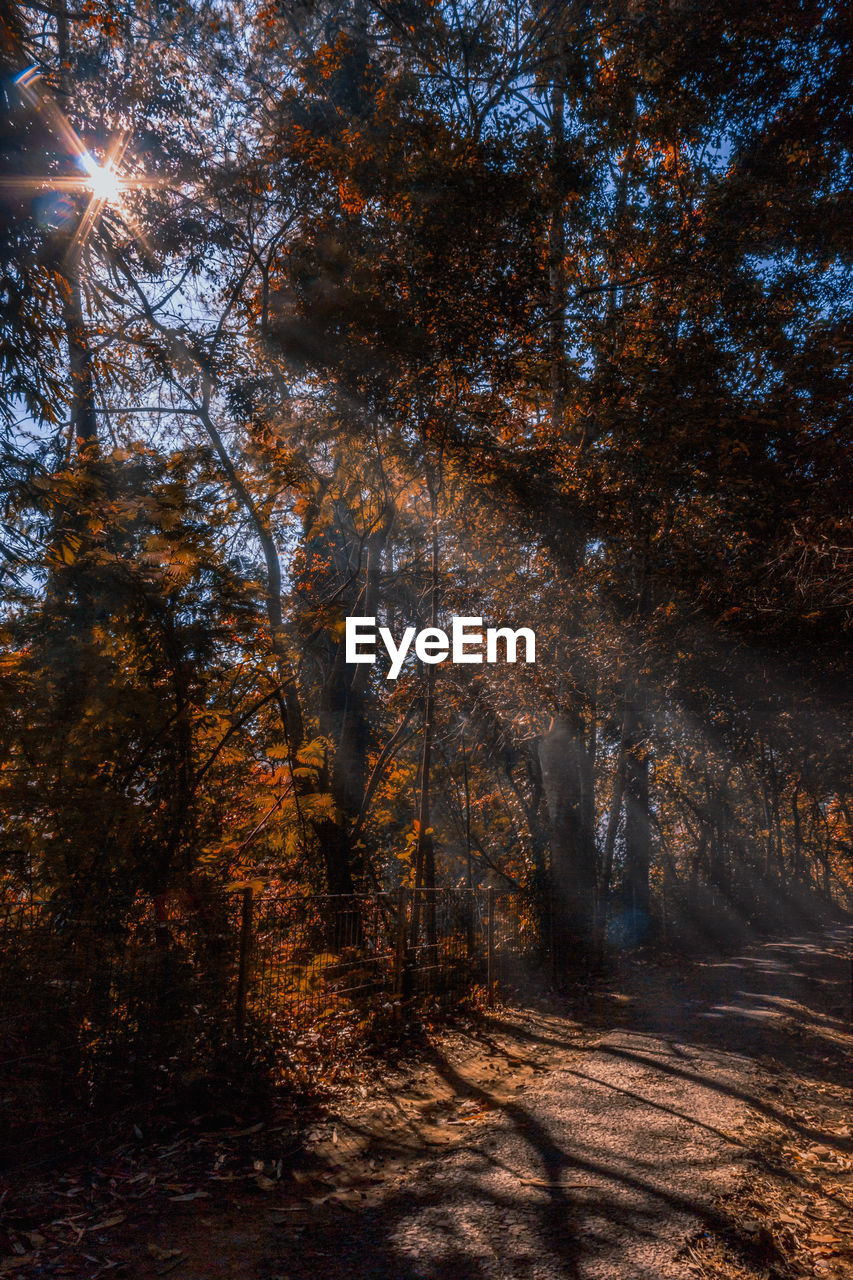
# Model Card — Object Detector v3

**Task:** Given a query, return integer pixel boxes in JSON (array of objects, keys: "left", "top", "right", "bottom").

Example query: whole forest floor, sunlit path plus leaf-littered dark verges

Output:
[{"left": 0, "top": 929, "right": 853, "bottom": 1280}]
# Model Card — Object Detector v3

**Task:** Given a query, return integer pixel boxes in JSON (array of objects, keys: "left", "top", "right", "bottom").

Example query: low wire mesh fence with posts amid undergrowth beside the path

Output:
[{"left": 0, "top": 888, "right": 543, "bottom": 1162}]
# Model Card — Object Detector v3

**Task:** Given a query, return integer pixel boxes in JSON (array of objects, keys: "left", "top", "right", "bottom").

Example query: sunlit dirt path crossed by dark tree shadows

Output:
[{"left": 233, "top": 940, "right": 849, "bottom": 1280}]
